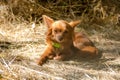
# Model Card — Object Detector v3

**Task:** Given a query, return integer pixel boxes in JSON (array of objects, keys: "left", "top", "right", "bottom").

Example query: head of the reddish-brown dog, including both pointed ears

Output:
[{"left": 43, "top": 15, "right": 80, "bottom": 43}]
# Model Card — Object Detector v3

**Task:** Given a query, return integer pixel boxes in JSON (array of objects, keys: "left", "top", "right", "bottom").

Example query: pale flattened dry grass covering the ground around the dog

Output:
[{"left": 0, "top": 1, "right": 120, "bottom": 80}]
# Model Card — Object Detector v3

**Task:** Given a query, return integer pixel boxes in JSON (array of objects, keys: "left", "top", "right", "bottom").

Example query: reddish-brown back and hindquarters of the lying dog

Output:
[{"left": 74, "top": 32, "right": 98, "bottom": 58}]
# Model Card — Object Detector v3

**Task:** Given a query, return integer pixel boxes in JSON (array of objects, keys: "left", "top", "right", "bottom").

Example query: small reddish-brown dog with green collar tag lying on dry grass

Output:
[{"left": 38, "top": 15, "right": 98, "bottom": 65}]
